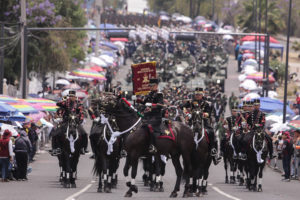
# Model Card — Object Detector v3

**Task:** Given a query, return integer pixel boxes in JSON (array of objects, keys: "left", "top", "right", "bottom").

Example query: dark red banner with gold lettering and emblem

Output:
[{"left": 131, "top": 62, "right": 156, "bottom": 95}]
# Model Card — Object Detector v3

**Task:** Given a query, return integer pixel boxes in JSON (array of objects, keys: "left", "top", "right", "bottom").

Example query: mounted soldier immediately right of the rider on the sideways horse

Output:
[{"left": 183, "top": 88, "right": 221, "bottom": 165}]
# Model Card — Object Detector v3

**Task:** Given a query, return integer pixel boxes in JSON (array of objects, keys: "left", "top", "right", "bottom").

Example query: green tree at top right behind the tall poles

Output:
[{"left": 237, "top": 0, "right": 286, "bottom": 34}]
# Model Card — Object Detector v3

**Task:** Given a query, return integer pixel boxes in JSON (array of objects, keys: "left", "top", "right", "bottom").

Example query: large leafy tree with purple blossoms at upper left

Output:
[{"left": 0, "top": 0, "right": 86, "bottom": 83}]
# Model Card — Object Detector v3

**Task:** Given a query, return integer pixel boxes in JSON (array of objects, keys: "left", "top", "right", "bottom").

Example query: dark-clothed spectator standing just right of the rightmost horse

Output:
[{"left": 282, "top": 131, "right": 293, "bottom": 182}]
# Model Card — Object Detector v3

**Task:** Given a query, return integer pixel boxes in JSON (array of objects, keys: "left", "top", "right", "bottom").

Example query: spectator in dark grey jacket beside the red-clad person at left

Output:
[{"left": 15, "top": 131, "right": 32, "bottom": 180}]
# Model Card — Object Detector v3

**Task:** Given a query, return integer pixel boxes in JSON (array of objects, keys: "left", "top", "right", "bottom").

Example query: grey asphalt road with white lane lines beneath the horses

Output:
[{"left": 0, "top": 55, "right": 300, "bottom": 200}]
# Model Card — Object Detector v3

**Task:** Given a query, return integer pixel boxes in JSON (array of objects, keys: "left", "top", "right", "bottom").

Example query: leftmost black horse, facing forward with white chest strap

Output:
[{"left": 57, "top": 114, "right": 83, "bottom": 188}]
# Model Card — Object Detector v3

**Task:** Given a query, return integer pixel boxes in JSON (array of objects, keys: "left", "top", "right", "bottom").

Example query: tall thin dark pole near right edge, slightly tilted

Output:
[{"left": 282, "top": 0, "right": 292, "bottom": 123}]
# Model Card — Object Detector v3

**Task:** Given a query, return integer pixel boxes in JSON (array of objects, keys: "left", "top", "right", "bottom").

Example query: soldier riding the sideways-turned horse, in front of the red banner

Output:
[{"left": 138, "top": 78, "right": 164, "bottom": 153}]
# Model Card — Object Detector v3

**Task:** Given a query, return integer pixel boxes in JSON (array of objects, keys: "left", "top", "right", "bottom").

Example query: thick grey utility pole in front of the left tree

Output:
[{"left": 20, "top": 0, "right": 27, "bottom": 99}]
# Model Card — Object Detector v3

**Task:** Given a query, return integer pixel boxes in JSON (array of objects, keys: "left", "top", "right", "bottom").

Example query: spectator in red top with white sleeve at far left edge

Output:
[{"left": 0, "top": 130, "right": 13, "bottom": 182}]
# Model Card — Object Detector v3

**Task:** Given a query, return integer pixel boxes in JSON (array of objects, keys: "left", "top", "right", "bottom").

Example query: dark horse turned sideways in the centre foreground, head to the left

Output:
[{"left": 102, "top": 95, "right": 195, "bottom": 197}]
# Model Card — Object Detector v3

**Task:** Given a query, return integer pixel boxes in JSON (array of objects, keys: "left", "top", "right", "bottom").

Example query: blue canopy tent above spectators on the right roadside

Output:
[{"left": 259, "top": 97, "right": 295, "bottom": 115}]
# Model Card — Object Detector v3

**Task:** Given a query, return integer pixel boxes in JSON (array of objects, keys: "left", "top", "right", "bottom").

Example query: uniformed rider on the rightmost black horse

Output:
[{"left": 247, "top": 99, "right": 275, "bottom": 159}]
